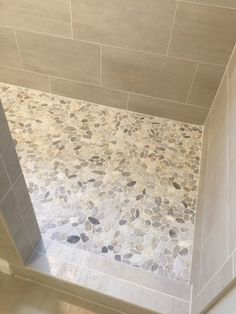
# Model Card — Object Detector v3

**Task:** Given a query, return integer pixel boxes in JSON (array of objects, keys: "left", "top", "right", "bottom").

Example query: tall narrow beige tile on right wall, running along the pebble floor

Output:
[{"left": 203, "top": 76, "right": 227, "bottom": 241}]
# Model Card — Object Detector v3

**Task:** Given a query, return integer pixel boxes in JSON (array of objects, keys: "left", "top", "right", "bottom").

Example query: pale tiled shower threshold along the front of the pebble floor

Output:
[{"left": 12, "top": 240, "right": 191, "bottom": 314}]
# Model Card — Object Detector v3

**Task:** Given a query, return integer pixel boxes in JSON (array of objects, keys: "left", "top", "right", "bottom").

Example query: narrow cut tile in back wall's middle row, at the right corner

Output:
[{"left": 188, "top": 64, "right": 225, "bottom": 108}]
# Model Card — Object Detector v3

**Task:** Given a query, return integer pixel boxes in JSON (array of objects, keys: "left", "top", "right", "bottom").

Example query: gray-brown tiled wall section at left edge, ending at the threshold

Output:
[{"left": 0, "top": 102, "right": 40, "bottom": 265}]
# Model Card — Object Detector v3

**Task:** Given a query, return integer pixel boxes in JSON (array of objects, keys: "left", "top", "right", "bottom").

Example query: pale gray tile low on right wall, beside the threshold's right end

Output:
[{"left": 200, "top": 213, "right": 228, "bottom": 288}]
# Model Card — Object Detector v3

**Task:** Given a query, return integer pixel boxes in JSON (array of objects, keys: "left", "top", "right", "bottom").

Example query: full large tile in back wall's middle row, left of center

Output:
[{"left": 17, "top": 31, "right": 100, "bottom": 84}]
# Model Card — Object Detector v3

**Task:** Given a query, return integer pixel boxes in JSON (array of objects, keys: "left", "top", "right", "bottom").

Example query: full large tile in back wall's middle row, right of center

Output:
[{"left": 102, "top": 47, "right": 196, "bottom": 101}]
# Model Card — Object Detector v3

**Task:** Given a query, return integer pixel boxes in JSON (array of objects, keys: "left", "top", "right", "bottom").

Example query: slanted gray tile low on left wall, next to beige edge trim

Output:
[{"left": 0, "top": 191, "right": 33, "bottom": 262}]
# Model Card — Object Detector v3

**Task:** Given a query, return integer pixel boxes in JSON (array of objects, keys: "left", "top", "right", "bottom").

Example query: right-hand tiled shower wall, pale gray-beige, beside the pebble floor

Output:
[{"left": 192, "top": 44, "right": 236, "bottom": 314}]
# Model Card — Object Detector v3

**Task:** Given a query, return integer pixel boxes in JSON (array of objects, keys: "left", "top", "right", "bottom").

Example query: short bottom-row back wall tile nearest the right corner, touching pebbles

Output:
[{"left": 128, "top": 94, "right": 208, "bottom": 124}]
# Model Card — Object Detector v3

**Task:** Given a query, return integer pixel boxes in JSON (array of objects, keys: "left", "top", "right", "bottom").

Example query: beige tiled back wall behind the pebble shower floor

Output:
[{"left": 0, "top": 0, "right": 236, "bottom": 124}]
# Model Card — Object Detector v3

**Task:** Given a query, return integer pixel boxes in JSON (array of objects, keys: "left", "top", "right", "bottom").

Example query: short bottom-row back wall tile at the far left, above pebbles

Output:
[{"left": 0, "top": 66, "right": 50, "bottom": 92}]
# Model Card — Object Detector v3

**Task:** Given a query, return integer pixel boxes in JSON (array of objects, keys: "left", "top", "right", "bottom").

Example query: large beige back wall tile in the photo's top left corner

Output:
[{"left": 0, "top": 0, "right": 71, "bottom": 37}]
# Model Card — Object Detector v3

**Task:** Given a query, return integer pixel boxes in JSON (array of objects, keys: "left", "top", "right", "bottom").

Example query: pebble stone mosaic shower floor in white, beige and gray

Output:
[{"left": 0, "top": 84, "right": 202, "bottom": 281}]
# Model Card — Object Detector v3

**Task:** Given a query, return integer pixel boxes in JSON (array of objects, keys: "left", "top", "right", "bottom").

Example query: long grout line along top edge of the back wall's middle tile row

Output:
[{"left": 0, "top": 24, "right": 226, "bottom": 67}]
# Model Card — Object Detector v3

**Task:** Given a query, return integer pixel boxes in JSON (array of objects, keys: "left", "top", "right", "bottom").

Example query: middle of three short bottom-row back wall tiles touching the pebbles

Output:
[{"left": 50, "top": 78, "right": 128, "bottom": 109}]
